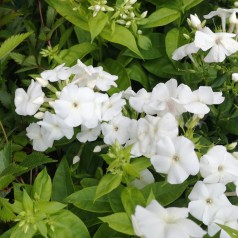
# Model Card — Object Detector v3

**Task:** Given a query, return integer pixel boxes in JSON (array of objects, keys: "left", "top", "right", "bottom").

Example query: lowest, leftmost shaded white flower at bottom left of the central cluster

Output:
[{"left": 26, "top": 123, "right": 54, "bottom": 151}]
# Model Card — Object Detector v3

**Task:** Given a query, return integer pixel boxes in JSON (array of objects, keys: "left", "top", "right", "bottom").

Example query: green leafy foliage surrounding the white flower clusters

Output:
[{"left": 0, "top": 0, "right": 238, "bottom": 238}]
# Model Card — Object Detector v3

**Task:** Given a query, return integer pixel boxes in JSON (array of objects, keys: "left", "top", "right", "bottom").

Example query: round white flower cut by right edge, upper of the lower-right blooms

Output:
[{"left": 200, "top": 145, "right": 238, "bottom": 184}]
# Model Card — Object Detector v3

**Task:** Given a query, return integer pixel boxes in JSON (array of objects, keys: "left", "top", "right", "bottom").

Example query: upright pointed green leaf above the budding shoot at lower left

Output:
[{"left": 32, "top": 169, "right": 52, "bottom": 201}]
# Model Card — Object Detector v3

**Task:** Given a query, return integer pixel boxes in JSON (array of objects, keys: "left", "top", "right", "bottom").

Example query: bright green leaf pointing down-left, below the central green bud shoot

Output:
[{"left": 95, "top": 174, "right": 122, "bottom": 201}]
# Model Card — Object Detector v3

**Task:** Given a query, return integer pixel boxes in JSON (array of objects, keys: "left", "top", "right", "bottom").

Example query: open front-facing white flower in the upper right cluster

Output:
[{"left": 195, "top": 27, "right": 238, "bottom": 63}]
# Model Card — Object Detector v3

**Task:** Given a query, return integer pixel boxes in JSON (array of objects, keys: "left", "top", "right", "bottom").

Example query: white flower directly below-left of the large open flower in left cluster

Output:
[{"left": 37, "top": 111, "right": 74, "bottom": 140}]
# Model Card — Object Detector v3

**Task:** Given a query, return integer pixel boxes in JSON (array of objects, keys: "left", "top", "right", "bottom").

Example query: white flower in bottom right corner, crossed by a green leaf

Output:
[{"left": 208, "top": 205, "right": 238, "bottom": 238}]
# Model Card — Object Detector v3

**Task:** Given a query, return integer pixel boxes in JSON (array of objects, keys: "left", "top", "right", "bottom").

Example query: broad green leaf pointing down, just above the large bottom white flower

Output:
[{"left": 121, "top": 187, "right": 146, "bottom": 217}]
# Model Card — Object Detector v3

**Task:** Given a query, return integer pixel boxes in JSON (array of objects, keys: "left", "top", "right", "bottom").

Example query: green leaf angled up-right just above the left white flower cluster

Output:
[{"left": 55, "top": 42, "right": 97, "bottom": 66}]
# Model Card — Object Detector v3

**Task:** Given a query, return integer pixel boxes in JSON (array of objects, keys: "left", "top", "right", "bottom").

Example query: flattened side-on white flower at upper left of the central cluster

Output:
[{"left": 40, "top": 64, "right": 71, "bottom": 82}]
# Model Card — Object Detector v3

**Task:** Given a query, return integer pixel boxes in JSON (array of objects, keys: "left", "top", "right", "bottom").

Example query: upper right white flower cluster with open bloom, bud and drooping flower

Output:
[{"left": 172, "top": 8, "right": 238, "bottom": 63}]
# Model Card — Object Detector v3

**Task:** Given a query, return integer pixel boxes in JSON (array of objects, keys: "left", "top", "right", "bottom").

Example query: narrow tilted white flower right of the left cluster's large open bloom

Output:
[{"left": 101, "top": 92, "right": 126, "bottom": 121}]
